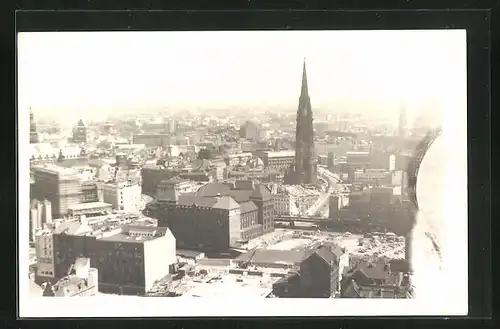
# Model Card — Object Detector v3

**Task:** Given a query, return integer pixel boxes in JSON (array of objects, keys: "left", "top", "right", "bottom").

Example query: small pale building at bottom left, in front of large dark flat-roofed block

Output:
[{"left": 52, "top": 257, "right": 99, "bottom": 297}]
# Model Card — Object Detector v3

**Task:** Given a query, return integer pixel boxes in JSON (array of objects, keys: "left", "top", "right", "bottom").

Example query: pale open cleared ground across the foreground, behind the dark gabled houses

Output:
[{"left": 143, "top": 229, "right": 405, "bottom": 298}]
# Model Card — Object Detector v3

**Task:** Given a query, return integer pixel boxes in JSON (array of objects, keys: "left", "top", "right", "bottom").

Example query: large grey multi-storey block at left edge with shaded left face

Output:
[{"left": 31, "top": 165, "right": 81, "bottom": 218}]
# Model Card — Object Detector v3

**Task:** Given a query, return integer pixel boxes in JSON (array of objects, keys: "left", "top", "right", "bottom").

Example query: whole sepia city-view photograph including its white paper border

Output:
[{"left": 17, "top": 30, "right": 468, "bottom": 317}]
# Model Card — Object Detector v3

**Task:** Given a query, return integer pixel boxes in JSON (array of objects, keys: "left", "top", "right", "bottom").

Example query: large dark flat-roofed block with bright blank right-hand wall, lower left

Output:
[{"left": 44, "top": 219, "right": 176, "bottom": 295}]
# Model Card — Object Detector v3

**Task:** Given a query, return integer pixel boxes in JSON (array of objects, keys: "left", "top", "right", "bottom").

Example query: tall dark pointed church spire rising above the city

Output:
[{"left": 294, "top": 59, "right": 317, "bottom": 184}]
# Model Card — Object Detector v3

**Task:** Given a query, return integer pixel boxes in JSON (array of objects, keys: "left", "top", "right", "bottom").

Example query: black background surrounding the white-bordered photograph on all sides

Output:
[{"left": 0, "top": 0, "right": 500, "bottom": 328}]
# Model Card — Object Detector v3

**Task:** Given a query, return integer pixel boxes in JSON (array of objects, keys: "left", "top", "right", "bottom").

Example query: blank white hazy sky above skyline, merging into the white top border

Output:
[{"left": 18, "top": 30, "right": 466, "bottom": 119}]
